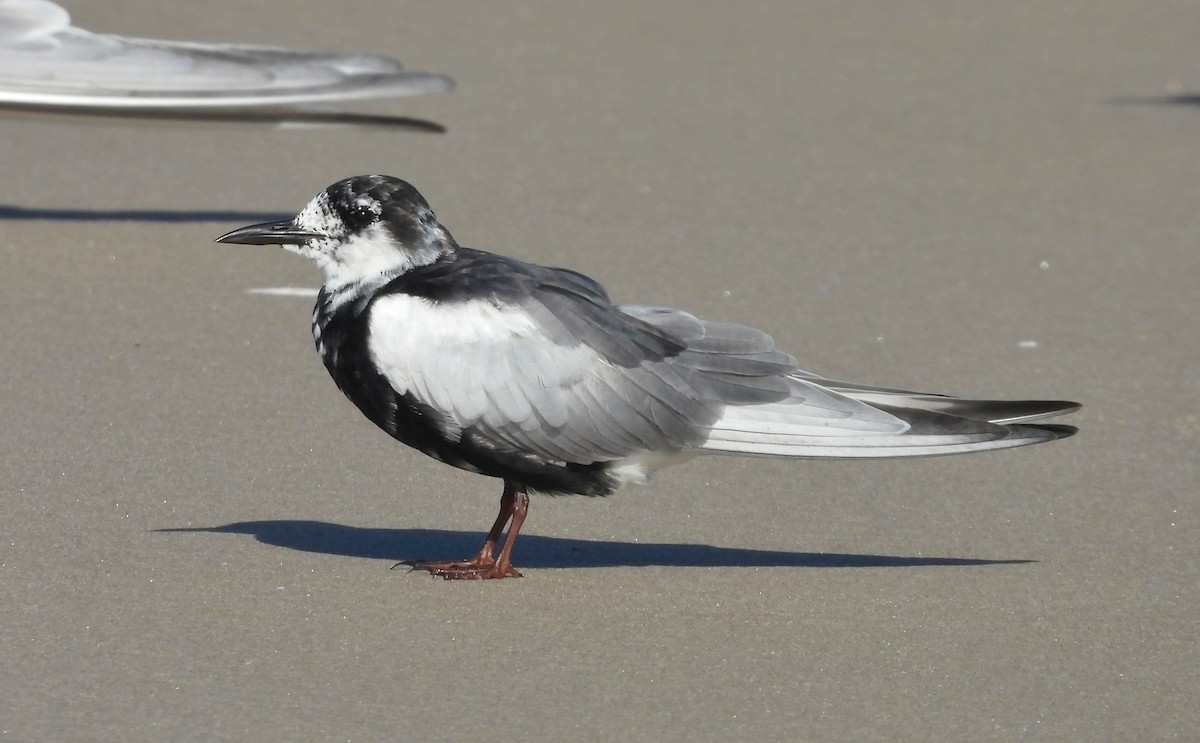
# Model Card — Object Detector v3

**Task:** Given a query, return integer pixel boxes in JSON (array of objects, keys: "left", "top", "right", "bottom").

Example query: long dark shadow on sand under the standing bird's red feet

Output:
[{"left": 155, "top": 521, "right": 1036, "bottom": 568}]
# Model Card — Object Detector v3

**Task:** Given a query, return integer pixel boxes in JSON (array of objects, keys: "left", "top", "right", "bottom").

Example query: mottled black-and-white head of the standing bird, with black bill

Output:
[{"left": 216, "top": 175, "right": 457, "bottom": 287}]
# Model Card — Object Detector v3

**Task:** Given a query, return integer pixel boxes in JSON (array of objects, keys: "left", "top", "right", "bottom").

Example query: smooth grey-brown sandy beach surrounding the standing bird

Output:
[{"left": 0, "top": 0, "right": 1200, "bottom": 742}]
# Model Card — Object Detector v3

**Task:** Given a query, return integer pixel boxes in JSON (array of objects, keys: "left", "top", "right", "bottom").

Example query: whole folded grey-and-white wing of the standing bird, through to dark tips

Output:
[{"left": 370, "top": 267, "right": 1072, "bottom": 478}]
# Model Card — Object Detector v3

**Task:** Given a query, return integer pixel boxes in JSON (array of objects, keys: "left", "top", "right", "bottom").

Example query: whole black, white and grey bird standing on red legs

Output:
[{"left": 217, "top": 175, "right": 1079, "bottom": 579}]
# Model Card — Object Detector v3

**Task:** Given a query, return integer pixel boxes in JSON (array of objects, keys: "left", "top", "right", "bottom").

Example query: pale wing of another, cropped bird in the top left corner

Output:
[{"left": 0, "top": 0, "right": 454, "bottom": 110}]
